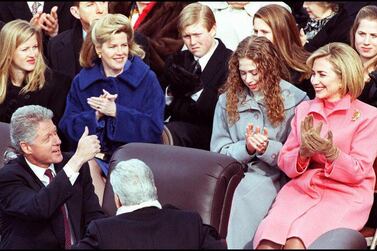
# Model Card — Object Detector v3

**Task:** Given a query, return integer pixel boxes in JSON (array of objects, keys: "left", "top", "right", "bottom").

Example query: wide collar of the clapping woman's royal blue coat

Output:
[{"left": 78, "top": 56, "right": 149, "bottom": 90}]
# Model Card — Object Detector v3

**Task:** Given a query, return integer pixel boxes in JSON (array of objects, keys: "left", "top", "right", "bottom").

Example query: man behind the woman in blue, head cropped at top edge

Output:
[{"left": 47, "top": 2, "right": 149, "bottom": 79}]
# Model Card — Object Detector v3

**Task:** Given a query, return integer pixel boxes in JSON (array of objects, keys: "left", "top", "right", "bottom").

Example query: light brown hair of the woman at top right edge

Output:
[{"left": 350, "top": 5, "right": 377, "bottom": 74}]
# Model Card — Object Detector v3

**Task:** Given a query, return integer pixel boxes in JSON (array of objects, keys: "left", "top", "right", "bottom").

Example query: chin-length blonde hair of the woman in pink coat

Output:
[{"left": 306, "top": 42, "right": 364, "bottom": 99}]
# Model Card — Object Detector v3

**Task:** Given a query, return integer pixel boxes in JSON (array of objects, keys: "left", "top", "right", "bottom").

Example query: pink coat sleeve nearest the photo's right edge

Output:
[{"left": 325, "top": 113, "right": 377, "bottom": 184}]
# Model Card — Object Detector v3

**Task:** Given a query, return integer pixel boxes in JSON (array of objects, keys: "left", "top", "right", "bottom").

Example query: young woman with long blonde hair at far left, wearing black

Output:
[{"left": 0, "top": 19, "right": 71, "bottom": 123}]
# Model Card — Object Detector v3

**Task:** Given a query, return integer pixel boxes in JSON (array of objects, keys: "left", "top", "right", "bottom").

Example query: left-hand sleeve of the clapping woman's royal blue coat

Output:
[{"left": 59, "top": 75, "right": 98, "bottom": 144}]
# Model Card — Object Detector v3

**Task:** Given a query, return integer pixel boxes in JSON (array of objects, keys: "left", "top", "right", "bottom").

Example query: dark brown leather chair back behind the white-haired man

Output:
[{"left": 102, "top": 143, "right": 244, "bottom": 239}]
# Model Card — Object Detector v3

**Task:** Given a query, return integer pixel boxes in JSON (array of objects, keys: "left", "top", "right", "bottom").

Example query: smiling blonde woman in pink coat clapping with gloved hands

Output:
[{"left": 253, "top": 43, "right": 377, "bottom": 249}]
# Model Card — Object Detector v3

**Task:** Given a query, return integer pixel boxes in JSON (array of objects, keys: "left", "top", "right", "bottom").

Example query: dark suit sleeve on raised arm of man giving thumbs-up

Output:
[{"left": 0, "top": 165, "right": 74, "bottom": 221}]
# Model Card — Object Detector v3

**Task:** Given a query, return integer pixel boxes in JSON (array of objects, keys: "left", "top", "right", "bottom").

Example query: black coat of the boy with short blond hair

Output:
[{"left": 161, "top": 39, "right": 232, "bottom": 150}]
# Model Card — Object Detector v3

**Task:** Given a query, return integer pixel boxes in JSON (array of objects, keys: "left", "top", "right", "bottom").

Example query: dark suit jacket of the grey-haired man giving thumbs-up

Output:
[{"left": 0, "top": 155, "right": 105, "bottom": 249}]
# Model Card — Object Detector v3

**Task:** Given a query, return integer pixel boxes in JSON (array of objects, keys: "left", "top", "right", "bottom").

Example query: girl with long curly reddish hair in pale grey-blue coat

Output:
[{"left": 211, "top": 36, "right": 308, "bottom": 249}]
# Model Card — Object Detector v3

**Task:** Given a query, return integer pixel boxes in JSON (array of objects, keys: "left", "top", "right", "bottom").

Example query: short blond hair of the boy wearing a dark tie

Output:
[{"left": 177, "top": 3, "right": 216, "bottom": 34}]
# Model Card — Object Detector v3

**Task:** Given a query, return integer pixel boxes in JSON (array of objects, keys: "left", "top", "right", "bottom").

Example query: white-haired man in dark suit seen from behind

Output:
[{"left": 75, "top": 159, "right": 226, "bottom": 249}]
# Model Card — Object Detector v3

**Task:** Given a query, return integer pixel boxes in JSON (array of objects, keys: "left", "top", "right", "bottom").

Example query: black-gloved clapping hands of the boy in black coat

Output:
[{"left": 166, "top": 63, "right": 202, "bottom": 97}]
